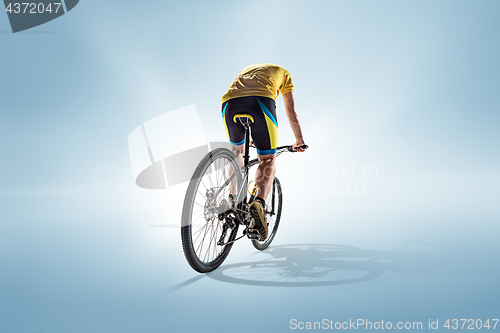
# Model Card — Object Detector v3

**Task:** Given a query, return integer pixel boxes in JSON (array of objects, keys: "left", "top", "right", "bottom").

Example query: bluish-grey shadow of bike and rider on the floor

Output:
[{"left": 169, "top": 239, "right": 461, "bottom": 291}]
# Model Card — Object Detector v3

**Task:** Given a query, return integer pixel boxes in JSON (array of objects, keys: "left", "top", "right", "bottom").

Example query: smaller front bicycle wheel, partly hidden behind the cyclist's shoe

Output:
[{"left": 252, "top": 178, "right": 283, "bottom": 251}]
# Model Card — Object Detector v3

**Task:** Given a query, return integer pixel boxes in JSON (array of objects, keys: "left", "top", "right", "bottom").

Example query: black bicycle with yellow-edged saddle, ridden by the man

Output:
[{"left": 181, "top": 115, "right": 308, "bottom": 273}]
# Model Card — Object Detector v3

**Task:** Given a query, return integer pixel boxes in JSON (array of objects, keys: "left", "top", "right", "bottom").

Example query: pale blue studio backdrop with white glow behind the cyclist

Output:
[{"left": 0, "top": 0, "right": 500, "bottom": 332}]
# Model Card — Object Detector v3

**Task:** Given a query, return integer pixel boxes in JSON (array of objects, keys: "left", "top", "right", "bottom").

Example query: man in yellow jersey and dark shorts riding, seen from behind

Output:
[{"left": 222, "top": 64, "right": 305, "bottom": 240}]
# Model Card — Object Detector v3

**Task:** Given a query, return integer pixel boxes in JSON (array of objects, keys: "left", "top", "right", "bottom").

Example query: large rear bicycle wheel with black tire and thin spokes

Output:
[{"left": 181, "top": 148, "right": 242, "bottom": 273}]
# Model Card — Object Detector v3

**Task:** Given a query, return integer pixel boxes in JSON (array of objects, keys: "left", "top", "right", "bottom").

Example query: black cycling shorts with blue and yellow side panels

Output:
[{"left": 222, "top": 96, "right": 278, "bottom": 155}]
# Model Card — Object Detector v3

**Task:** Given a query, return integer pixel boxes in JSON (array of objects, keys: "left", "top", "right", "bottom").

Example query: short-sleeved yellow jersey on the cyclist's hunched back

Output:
[{"left": 222, "top": 64, "right": 293, "bottom": 103}]
